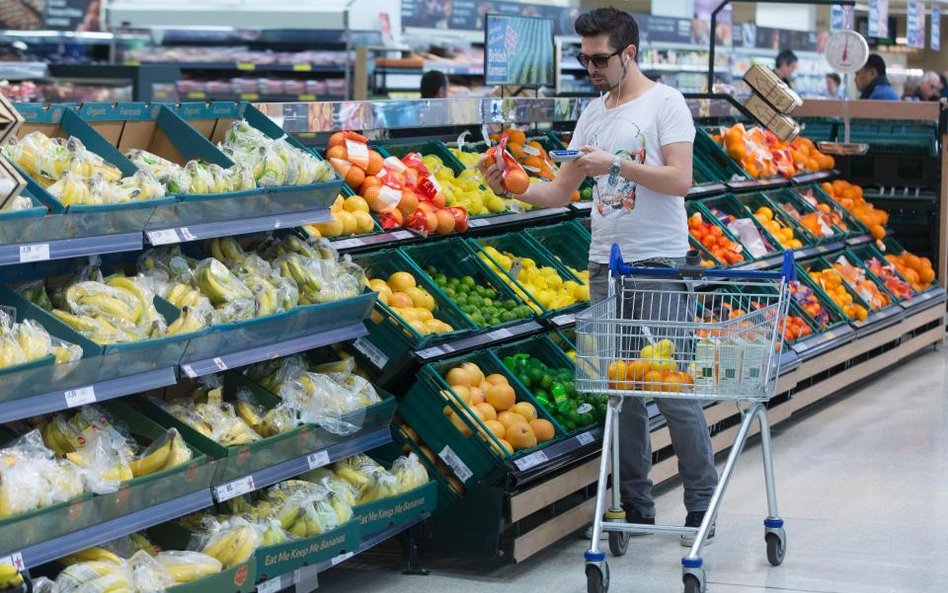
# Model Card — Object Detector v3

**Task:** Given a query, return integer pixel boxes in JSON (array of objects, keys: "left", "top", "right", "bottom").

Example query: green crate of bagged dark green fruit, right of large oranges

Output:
[{"left": 491, "top": 335, "right": 606, "bottom": 435}]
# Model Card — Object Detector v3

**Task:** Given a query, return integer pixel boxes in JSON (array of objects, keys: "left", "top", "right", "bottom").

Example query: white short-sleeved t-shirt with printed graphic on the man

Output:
[{"left": 569, "top": 84, "right": 695, "bottom": 263}]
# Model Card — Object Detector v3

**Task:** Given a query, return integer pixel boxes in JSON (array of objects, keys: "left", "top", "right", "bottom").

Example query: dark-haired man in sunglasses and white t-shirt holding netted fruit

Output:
[{"left": 480, "top": 8, "right": 717, "bottom": 546}]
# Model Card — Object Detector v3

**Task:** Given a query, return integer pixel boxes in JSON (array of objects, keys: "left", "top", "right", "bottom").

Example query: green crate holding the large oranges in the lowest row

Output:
[{"left": 399, "top": 351, "right": 563, "bottom": 485}]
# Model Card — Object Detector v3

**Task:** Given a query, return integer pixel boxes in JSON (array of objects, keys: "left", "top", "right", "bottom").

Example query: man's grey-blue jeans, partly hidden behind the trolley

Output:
[{"left": 589, "top": 262, "right": 718, "bottom": 517}]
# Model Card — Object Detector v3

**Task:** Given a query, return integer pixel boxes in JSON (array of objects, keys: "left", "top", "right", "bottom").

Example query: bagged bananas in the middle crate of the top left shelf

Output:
[{"left": 125, "top": 149, "right": 257, "bottom": 194}]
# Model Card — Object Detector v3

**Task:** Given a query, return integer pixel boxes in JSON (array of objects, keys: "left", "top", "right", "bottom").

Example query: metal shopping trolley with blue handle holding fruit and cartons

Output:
[{"left": 576, "top": 245, "right": 796, "bottom": 593}]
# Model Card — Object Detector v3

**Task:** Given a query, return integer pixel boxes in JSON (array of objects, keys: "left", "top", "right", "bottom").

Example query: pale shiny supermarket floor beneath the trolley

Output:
[{"left": 320, "top": 346, "right": 948, "bottom": 593}]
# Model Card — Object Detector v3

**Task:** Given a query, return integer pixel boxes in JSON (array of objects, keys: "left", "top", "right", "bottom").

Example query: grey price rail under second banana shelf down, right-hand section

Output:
[{"left": 181, "top": 320, "right": 368, "bottom": 378}]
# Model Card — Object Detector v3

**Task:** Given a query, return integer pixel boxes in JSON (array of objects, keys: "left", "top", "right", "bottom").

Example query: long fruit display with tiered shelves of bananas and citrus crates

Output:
[{"left": 0, "top": 93, "right": 948, "bottom": 592}]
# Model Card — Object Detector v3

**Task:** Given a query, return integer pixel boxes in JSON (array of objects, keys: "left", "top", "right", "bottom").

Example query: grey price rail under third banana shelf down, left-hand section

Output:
[{"left": 19, "top": 488, "right": 213, "bottom": 568}]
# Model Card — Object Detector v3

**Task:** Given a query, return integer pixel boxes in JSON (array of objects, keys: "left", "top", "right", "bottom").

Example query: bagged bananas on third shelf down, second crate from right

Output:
[{"left": 156, "top": 387, "right": 260, "bottom": 447}]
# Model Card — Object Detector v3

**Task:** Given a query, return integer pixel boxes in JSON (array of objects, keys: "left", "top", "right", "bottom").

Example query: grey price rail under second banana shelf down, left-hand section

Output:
[{"left": 0, "top": 366, "right": 177, "bottom": 422}]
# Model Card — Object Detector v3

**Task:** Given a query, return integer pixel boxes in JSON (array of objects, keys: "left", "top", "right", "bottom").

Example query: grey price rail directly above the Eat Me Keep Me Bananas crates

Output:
[{"left": 211, "top": 424, "right": 392, "bottom": 502}]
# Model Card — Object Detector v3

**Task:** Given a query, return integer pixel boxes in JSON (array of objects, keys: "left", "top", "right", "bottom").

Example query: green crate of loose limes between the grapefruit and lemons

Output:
[{"left": 402, "top": 238, "right": 533, "bottom": 329}]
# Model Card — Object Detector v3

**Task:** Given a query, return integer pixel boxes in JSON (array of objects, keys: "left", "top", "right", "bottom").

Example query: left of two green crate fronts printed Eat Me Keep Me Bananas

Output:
[{"left": 254, "top": 519, "right": 360, "bottom": 581}]
